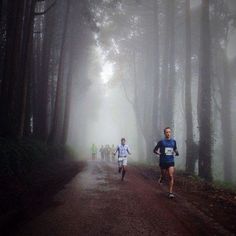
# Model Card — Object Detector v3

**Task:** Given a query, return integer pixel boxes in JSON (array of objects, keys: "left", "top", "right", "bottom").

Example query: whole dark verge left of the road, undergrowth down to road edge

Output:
[{"left": 0, "top": 138, "right": 83, "bottom": 231}]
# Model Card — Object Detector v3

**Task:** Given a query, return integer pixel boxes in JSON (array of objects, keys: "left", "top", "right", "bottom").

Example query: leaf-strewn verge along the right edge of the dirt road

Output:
[{"left": 133, "top": 162, "right": 236, "bottom": 235}]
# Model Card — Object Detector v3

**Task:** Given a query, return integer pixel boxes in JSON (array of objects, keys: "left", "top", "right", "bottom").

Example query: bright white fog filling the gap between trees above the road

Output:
[{"left": 68, "top": 43, "right": 145, "bottom": 160}]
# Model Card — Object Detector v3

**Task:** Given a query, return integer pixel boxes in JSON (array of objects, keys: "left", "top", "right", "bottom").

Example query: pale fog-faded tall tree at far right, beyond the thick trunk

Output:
[{"left": 211, "top": 0, "right": 235, "bottom": 181}]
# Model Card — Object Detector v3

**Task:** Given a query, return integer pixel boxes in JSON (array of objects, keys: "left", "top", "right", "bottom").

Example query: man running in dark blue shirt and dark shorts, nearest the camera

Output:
[{"left": 153, "top": 127, "right": 179, "bottom": 198}]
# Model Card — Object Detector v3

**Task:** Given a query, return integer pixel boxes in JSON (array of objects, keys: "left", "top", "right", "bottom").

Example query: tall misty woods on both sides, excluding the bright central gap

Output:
[{"left": 0, "top": 0, "right": 236, "bottom": 181}]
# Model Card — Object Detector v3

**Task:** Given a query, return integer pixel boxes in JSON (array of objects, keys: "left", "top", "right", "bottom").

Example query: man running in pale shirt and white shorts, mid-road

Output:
[{"left": 113, "top": 138, "right": 131, "bottom": 181}]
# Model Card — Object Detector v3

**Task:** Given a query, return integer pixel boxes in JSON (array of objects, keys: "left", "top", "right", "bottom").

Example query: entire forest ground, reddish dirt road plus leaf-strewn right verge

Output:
[{"left": 5, "top": 161, "right": 236, "bottom": 236}]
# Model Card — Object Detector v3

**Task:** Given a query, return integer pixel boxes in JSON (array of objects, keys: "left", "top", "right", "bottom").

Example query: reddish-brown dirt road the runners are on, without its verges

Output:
[{"left": 14, "top": 161, "right": 233, "bottom": 236}]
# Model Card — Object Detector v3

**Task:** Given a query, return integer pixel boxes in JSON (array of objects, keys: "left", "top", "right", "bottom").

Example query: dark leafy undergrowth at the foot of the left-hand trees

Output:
[{"left": 0, "top": 138, "right": 75, "bottom": 177}]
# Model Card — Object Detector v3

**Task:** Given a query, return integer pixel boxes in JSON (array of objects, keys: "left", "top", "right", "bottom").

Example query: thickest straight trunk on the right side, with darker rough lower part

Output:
[{"left": 198, "top": 0, "right": 212, "bottom": 180}]
